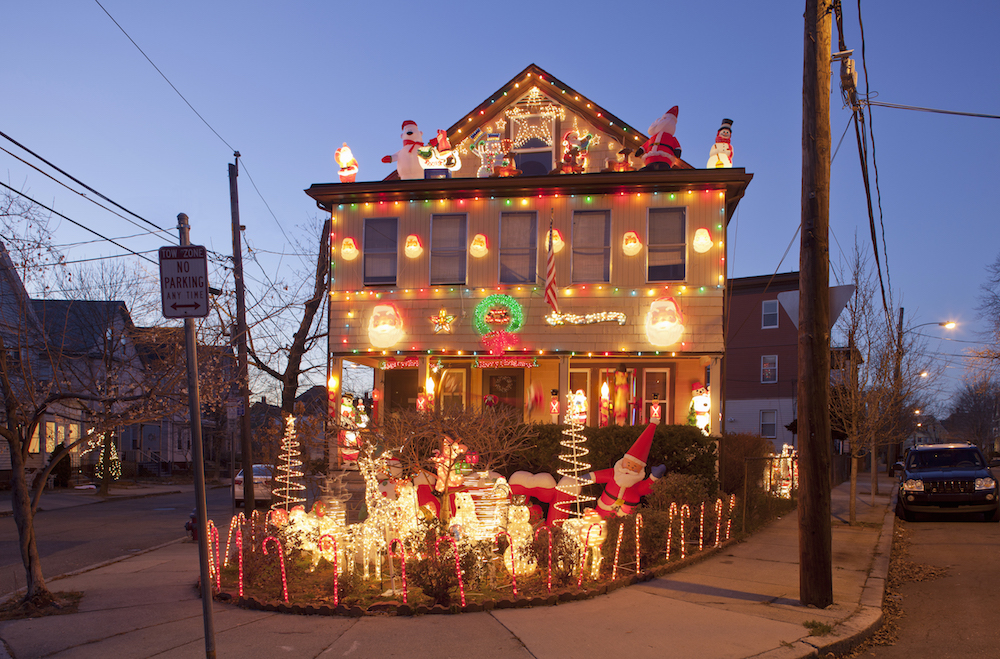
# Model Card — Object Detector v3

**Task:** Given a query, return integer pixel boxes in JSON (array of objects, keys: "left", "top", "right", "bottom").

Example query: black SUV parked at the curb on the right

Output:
[{"left": 896, "top": 444, "right": 1000, "bottom": 522}]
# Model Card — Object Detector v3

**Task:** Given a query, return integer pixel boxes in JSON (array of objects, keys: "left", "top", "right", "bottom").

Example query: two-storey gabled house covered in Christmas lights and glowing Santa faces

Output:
[{"left": 306, "top": 65, "right": 752, "bottom": 462}]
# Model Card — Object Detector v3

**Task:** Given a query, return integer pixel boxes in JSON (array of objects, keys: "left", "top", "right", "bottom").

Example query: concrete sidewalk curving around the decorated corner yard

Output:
[{"left": 0, "top": 475, "right": 894, "bottom": 659}]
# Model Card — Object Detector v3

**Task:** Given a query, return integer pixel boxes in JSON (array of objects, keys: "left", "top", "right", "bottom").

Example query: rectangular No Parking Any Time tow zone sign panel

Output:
[{"left": 160, "top": 245, "right": 208, "bottom": 318}]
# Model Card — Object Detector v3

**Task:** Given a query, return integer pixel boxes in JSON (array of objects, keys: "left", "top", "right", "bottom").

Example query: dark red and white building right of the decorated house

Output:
[{"left": 725, "top": 272, "right": 858, "bottom": 452}]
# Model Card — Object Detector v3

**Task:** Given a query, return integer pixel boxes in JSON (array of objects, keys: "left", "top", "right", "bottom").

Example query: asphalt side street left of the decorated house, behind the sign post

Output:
[{"left": 0, "top": 488, "right": 232, "bottom": 596}]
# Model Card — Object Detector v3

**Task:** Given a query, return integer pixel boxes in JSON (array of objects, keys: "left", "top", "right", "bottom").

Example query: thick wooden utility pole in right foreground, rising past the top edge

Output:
[{"left": 798, "top": 0, "right": 833, "bottom": 608}]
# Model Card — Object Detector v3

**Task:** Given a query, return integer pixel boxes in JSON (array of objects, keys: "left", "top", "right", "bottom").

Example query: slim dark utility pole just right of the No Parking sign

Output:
[{"left": 229, "top": 156, "right": 254, "bottom": 519}]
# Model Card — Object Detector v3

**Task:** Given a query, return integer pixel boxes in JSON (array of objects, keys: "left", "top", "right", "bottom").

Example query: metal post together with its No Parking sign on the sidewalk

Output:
[{"left": 160, "top": 218, "right": 220, "bottom": 659}]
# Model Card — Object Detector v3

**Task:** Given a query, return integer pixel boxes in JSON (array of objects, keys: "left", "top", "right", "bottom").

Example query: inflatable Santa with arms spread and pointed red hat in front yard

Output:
[{"left": 583, "top": 423, "right": 667, "bottom": 518}]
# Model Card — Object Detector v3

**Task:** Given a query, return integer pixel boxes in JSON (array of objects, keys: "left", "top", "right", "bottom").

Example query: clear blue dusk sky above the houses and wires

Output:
[{"left": 0, "top": 0, "right": 1000, "bottom": 412}]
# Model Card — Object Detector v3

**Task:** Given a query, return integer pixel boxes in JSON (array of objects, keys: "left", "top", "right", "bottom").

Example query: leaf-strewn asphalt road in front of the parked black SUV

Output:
[{"left": 858, "top": 514, "right": 1000, "bottom": 659}]
